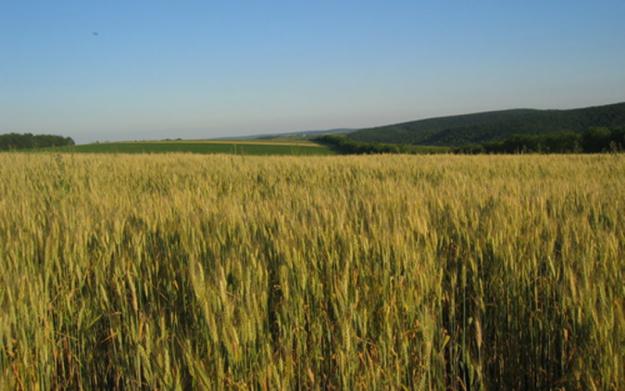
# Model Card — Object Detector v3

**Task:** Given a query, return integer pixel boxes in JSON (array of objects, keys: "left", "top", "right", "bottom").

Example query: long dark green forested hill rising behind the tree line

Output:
[{"left": 348, "top": 103, "right": 625, "bottom": 146}]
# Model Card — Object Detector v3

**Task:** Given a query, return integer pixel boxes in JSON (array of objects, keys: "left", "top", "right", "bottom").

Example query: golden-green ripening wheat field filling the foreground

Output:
[{"left": 0, "top": 153, "right": 625, "bottom": 390}]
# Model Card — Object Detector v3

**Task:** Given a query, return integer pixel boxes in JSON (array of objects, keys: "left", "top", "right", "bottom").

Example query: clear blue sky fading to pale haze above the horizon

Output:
[{"left": 0, "top": 0, "right": 625, "bottom": 142}]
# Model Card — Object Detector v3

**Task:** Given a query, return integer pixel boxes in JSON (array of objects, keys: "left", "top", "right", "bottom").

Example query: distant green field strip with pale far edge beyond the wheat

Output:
[{"left": 46, "top": 140, "right": 334, "bottom": 155}]
